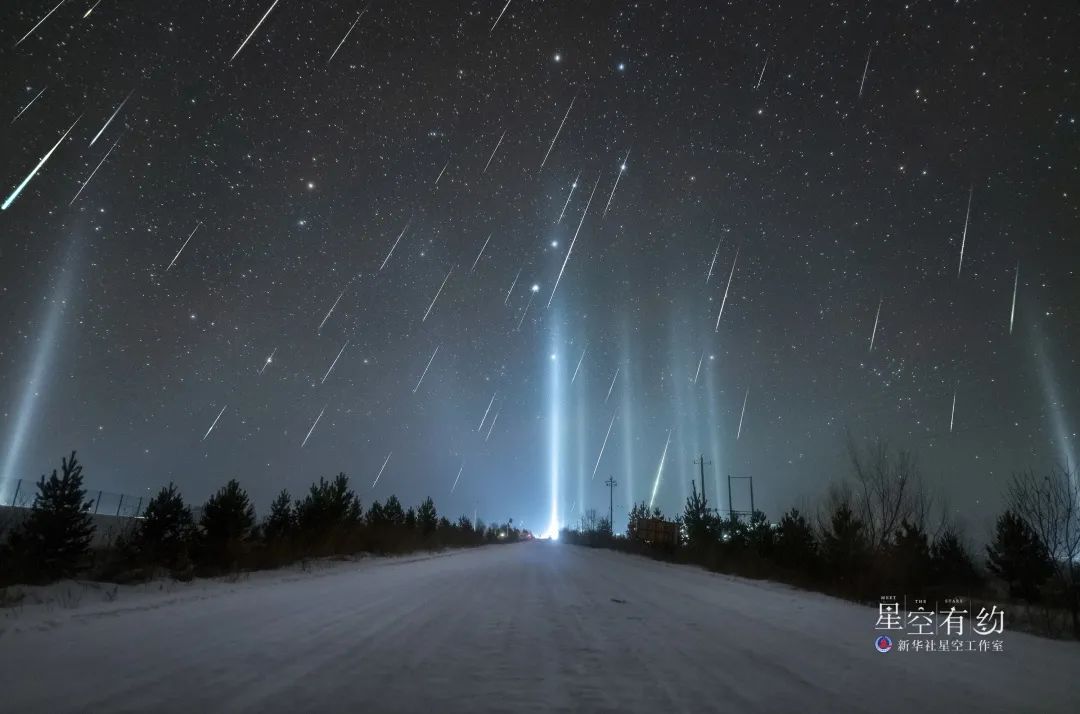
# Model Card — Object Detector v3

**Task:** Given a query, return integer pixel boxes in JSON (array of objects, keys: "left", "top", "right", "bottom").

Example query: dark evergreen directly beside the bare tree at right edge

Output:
[{"left": 986, "top": 510, "right": 1054, "bottom": 602}]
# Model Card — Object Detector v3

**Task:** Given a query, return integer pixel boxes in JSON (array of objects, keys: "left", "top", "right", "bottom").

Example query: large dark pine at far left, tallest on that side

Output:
[{"left": 9, "top": 452, "right": 94, "bottom": 580}]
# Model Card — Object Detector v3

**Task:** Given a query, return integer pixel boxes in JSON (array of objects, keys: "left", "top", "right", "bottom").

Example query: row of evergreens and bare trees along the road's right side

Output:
[{"left": 562, "top": 442, "right": 1080, "bottom": 638}]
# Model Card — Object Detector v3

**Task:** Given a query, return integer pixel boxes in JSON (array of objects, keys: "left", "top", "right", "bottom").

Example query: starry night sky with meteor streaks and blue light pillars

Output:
[{"left": 0, "top": 0, "right": 1080, "bottom": 534}]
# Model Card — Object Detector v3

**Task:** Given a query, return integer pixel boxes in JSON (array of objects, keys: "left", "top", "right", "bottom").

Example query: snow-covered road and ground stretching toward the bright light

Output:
[{"left": 0, "top": 542, "right": 1080, "bottom": 714}]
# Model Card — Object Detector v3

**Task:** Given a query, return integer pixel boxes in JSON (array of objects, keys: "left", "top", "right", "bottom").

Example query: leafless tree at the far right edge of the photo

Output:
[{"left": 1009, "top": 467, "right": 1080, "bottom": 637}]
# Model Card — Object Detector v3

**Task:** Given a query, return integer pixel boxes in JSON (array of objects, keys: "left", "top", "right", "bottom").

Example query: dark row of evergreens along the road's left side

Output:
[{"left": 0, "top": 452, "right": 522, "bottom": 585}]
